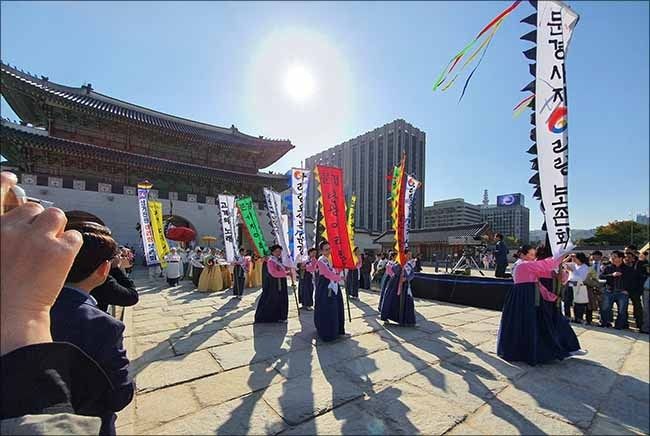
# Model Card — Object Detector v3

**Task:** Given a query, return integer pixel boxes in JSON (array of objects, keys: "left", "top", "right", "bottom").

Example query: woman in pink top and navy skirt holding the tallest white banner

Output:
[{"left": 497, "top": 245, "right": 580, "bottom": 365}]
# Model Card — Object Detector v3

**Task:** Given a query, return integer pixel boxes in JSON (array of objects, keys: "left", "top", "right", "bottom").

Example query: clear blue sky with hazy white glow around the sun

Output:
[{"left": 1, "top": 1, "right": 649, "bottom": 229}]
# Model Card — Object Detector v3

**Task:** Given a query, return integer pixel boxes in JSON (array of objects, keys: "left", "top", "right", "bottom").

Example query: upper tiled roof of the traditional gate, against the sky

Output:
[{"left": 0, "top": 62, "right": 293, "bottom": 155}]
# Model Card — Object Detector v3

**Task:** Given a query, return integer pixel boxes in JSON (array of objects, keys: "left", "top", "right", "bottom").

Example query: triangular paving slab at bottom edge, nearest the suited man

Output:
[{"left": 144, "top": 393, "right": 288, "bottom": 435}]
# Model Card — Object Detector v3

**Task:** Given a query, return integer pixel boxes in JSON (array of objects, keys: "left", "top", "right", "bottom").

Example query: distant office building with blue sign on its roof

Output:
[{"left": 480, "top": 194, "right": 530, "bottom": 244}]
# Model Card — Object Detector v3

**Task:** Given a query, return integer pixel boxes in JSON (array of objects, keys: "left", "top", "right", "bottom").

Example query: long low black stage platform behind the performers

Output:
[{"left": 411, "top": 273, "right": 513, "bottom": 310}]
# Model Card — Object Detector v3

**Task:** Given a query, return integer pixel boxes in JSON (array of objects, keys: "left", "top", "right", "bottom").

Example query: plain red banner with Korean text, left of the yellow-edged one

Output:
[{"left": 315, "top": 165, "right": 355, "bottom": 269}]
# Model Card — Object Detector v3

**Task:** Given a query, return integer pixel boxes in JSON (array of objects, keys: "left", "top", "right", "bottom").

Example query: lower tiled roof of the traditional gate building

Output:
[{"left": 0, "top": 120, "right": 286, "bottom": 183}]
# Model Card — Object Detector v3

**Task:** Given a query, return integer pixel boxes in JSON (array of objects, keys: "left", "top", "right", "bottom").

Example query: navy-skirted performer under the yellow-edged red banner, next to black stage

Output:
[{"left": 381, "top": 248, "right": 415, "bottom": 326}]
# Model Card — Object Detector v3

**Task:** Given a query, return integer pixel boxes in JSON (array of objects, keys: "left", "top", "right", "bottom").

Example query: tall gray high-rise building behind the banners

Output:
[{"left": 305, "top": 119, "right": 426, "bottom": 232}]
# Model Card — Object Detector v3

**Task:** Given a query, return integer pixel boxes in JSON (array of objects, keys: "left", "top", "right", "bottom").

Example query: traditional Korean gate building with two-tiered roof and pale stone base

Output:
[{"left": 0, "top": 63, "right": 293, "bottom": 247}]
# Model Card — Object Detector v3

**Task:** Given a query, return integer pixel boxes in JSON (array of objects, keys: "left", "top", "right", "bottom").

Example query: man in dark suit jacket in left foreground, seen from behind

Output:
[{"left": 50, "top": 222, "right": 134, "bottom": 434}]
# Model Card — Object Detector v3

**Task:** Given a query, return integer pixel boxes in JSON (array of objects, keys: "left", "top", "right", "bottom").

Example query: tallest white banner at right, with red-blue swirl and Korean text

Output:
[{"left": 535, "top": 1, "right": 579, "bottom": 255}]
